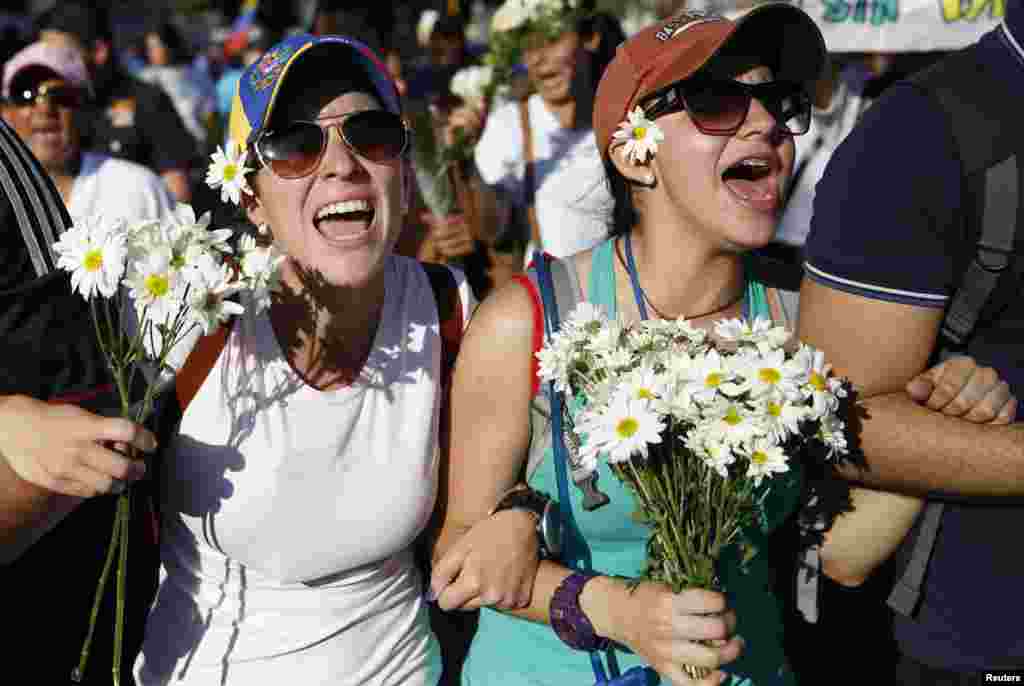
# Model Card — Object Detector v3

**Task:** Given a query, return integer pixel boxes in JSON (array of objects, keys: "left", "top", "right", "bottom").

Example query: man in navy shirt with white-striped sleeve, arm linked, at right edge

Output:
[{"left": 800, "top": 0, "right": 1024, "bottom": 685}]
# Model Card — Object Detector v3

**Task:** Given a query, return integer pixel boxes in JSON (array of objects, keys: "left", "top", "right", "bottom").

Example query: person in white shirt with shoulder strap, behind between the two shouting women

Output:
[{"left": 447, "top": 0, "right": 625, "bottom": 262}]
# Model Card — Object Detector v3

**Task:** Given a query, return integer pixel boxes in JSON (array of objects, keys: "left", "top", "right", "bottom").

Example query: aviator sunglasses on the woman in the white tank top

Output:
[{"left": 255, "top": 110, "right": 409, "bottom": 179}]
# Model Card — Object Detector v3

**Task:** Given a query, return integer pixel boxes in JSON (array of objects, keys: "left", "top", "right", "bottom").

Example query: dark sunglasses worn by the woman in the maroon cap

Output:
[{"left": 640, "top": 80, "right": 811, "bottom": 136}]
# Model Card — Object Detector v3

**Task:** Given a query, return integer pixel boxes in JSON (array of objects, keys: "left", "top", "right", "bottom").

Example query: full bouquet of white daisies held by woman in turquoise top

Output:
[{"left": 538, "top": 303, "right": 853, "bottom": 676}]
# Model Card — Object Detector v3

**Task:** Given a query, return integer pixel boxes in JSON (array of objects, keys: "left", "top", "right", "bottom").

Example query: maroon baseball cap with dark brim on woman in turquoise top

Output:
[{"left": 594, "top": 2, "right": 828, "bottom": 155}]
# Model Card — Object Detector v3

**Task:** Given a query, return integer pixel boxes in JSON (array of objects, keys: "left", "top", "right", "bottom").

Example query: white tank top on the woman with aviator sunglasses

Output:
[{"left": 135, "top": 257, "right": 474, "bottom": 686}]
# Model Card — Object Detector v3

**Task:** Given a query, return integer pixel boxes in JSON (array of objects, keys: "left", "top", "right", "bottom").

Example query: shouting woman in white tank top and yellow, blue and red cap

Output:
[{"left": 135, "top": 35, "right": 473, "bottom": 686}]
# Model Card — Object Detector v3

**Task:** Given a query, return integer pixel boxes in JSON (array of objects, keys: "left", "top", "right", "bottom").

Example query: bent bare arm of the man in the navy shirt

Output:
[{"left": 799, "top": 278, "right": 1024, "bottom": 497}]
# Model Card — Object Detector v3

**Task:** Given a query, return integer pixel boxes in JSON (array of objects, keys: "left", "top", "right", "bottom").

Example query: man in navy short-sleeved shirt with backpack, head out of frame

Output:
[{"left": 800, "top": 0, "right": 1024, "bottom": 685}]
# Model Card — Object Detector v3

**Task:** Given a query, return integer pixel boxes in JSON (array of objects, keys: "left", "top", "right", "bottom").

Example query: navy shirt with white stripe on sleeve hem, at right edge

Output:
[{"left": 806, "top": 17, "right": 1024, "bottom": 671}]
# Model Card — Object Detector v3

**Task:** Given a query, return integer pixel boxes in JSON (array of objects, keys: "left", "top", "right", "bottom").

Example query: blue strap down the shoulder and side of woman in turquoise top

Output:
[{"left": 534, "top": 253, "right": 593, "bottom": 571}]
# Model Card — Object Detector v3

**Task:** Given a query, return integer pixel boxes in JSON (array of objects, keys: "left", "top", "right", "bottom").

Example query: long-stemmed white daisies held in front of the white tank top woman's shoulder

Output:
[{"left": 53, "top": 204, "right": 284, "bottom": 684}]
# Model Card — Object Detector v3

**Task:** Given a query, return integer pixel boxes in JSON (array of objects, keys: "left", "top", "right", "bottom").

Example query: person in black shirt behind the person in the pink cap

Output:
[{"left": 36, "top": 1, "right": 198, "bottom": 202}]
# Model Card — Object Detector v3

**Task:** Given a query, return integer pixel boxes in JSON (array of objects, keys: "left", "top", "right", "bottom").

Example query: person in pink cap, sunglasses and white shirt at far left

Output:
[{"left": 3, "top": 43, "right": 176, "bottom": 221}]
